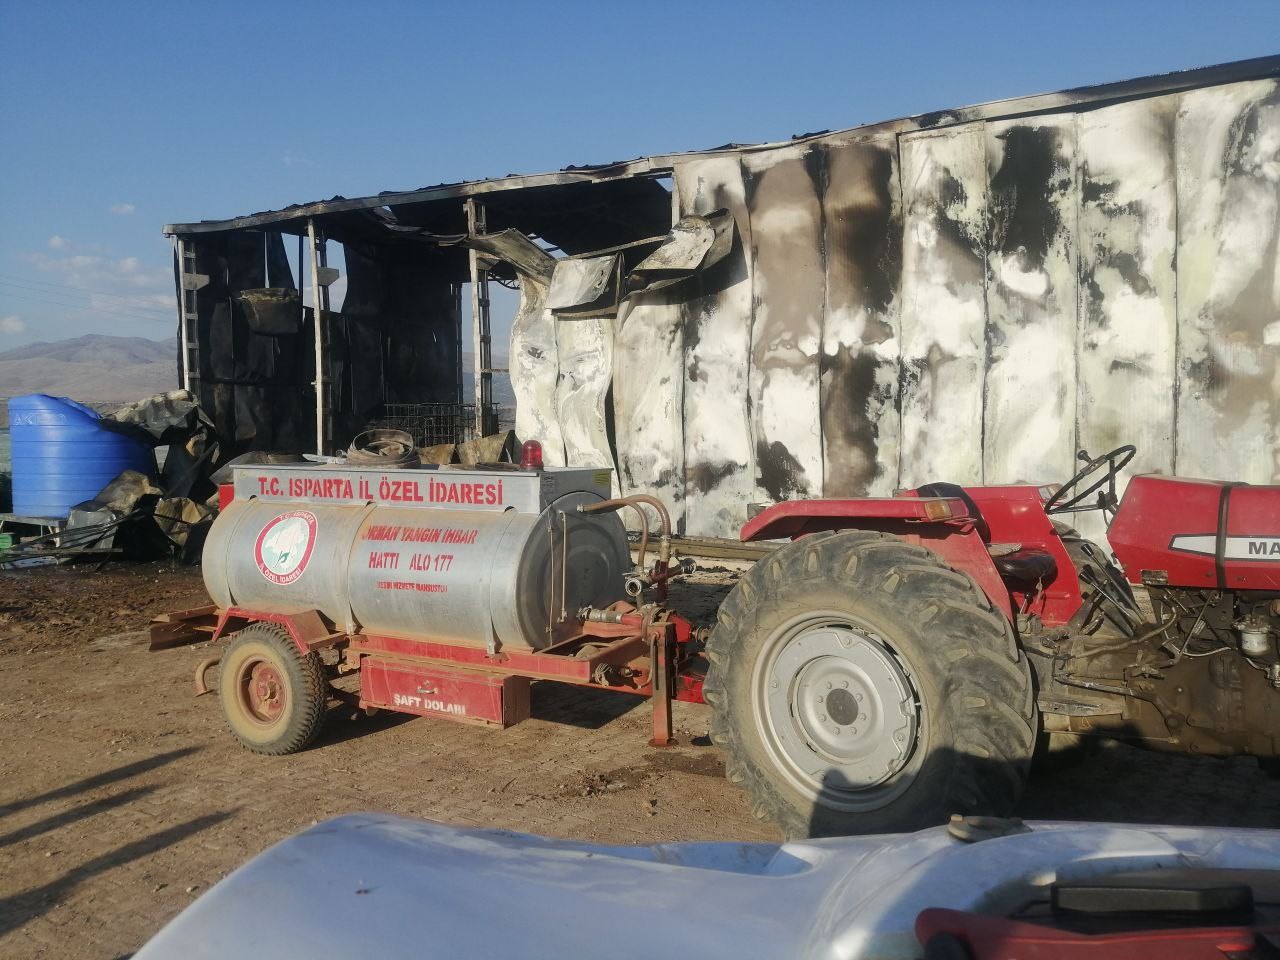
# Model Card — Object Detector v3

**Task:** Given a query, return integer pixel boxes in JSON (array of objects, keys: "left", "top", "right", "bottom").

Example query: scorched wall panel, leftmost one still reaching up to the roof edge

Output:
[{"left": 675, "top": 156, "right": 755, "bottom": 538}]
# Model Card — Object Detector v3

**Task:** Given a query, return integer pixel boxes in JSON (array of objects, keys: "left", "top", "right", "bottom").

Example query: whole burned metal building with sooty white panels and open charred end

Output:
[{"left": 166, "top": 58, "right": 1280, "bottom": 536}]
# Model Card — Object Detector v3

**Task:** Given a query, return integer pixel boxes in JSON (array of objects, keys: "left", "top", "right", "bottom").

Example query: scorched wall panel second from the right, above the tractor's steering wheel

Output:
[{"left": 1076, "top": 97, "right": 1178, "bottom": 496}]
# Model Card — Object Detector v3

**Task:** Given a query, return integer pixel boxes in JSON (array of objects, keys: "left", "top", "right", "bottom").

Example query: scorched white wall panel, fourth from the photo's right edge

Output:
[{"left": 900, "top": 123, "right": 987, "bottom": 486}]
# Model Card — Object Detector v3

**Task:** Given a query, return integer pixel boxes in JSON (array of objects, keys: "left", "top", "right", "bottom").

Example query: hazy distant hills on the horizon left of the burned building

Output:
[{"left": 0, "top": 334, "right": 178, "bottom": 417}]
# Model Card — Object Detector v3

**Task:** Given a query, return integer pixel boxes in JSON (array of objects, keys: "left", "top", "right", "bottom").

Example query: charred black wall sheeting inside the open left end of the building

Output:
[{"left": 184, "top": 229, "right": 462, "bottom": 456}]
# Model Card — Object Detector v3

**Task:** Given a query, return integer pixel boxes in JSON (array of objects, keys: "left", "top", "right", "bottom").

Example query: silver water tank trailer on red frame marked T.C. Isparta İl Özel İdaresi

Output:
[{"left": 152, "top": 443, "right": 705, "bottom": 755}]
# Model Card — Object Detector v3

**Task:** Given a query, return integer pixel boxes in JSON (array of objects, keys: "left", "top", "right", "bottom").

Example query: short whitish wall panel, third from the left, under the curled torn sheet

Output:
[{"left": 613, "top": 291, "right": 685, "bottom": 531}]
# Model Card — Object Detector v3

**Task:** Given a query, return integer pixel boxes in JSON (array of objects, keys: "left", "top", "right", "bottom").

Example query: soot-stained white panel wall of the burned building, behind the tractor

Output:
[{"left": 524, "top": 73, "right": 1280, "bottom": 536}]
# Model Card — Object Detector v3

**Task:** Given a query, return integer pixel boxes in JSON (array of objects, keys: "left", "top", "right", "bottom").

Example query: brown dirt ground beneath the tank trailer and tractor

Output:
[{"left": 0, "top": 564, "right": 1280, "bottom": 960}]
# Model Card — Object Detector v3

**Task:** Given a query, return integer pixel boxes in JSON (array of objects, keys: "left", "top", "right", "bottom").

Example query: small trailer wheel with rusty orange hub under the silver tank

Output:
[{"left": 218, "top": 623, "right": 328, "bottom": 756}]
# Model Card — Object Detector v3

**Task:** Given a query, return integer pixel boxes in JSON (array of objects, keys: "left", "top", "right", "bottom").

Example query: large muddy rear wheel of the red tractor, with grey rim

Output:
[{"left": 704, "top": 530, "right": 1037, "bottom": 838}]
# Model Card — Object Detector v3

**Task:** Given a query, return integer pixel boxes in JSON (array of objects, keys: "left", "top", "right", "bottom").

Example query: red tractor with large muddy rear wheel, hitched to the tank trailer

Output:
[{"left": 704, "top": 445, "right": 1280, "bottom": 836}]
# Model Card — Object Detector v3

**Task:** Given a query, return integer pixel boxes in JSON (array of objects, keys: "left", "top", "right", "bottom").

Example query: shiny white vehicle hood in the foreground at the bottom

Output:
[{"left": 136, "top": 814, "right": 1280, "bottom": 960}]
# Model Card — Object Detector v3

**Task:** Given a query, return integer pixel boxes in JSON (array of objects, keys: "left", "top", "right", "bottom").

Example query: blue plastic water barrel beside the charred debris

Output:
[{"left": 9, "top": 393, "right": 155, "bottom": 520}]
